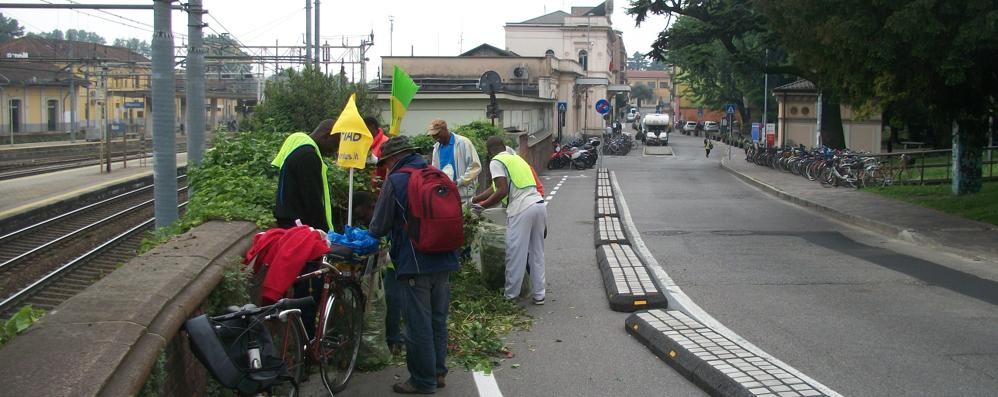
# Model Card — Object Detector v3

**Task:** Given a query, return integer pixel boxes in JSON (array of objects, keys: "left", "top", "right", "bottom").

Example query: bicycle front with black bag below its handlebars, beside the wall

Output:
[{"left": 184, "top": 297, "right": 315, "bottom": 396}]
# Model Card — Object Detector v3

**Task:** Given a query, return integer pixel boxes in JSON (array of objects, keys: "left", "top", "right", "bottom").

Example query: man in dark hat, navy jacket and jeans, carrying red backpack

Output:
[{"left": 370, "top": 136, "right": 463, "bottom": 394}]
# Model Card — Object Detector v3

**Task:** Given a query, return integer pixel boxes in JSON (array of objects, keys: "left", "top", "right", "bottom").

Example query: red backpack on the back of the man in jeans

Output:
[{"left": 399, "top": 167, "right": 464, "bottom": 254}]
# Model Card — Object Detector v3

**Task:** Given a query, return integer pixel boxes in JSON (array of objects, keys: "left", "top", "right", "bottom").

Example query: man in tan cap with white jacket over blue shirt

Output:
[{"left": 427, "top": 119, "right": 482, "bottom": 201}]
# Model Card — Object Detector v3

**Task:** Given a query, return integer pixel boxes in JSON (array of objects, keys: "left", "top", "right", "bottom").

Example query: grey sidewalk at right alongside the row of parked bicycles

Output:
[{"left": 718, "top": 144, "right": 998, "bottom": 262}]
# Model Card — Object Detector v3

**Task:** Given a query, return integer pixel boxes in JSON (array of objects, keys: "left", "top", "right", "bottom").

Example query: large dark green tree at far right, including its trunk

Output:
[{"left": 755, "top": 0, "right": 998, "bottom": 193}]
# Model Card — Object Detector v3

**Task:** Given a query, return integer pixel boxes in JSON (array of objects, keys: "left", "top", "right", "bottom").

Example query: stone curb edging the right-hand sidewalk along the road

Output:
[{"left": 721, "top": 160, "right": 940, "bottom": 246}]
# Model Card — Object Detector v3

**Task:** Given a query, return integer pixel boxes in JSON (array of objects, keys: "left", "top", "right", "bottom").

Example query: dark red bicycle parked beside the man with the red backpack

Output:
[{"left": 261, "top": 246, "right": 377, "bottom": 395}]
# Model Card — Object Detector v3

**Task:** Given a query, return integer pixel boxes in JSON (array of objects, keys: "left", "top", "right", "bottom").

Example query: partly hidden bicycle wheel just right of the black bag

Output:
[{"left": 267, "top": 315, "right": 307, "bottom": 397}]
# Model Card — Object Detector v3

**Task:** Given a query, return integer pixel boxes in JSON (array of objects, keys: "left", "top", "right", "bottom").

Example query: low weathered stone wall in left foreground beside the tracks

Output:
[{"left": 0, "top": 222, "right": 257, "bottom": 396}]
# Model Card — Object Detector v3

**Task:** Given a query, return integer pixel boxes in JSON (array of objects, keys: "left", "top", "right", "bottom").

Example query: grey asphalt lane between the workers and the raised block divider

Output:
[{"left": 302, "top": 162, "right": 706, "bottom": 397}]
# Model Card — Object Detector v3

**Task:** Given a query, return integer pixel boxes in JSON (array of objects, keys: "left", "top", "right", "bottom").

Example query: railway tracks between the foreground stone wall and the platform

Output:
[{"left": 0, "top": 176, "right": 187, "bottom": 318}]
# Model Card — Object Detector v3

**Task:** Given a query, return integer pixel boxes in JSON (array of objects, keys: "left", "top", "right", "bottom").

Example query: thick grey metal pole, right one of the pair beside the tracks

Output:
[{"left": 186, "top": 0, "right": 205, "bottom": 165}]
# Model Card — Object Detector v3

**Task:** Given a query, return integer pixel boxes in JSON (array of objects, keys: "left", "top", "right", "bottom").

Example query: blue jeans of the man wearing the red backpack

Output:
[{"left": 398, "top": 272, "right": 450, "bottom": 391}]
